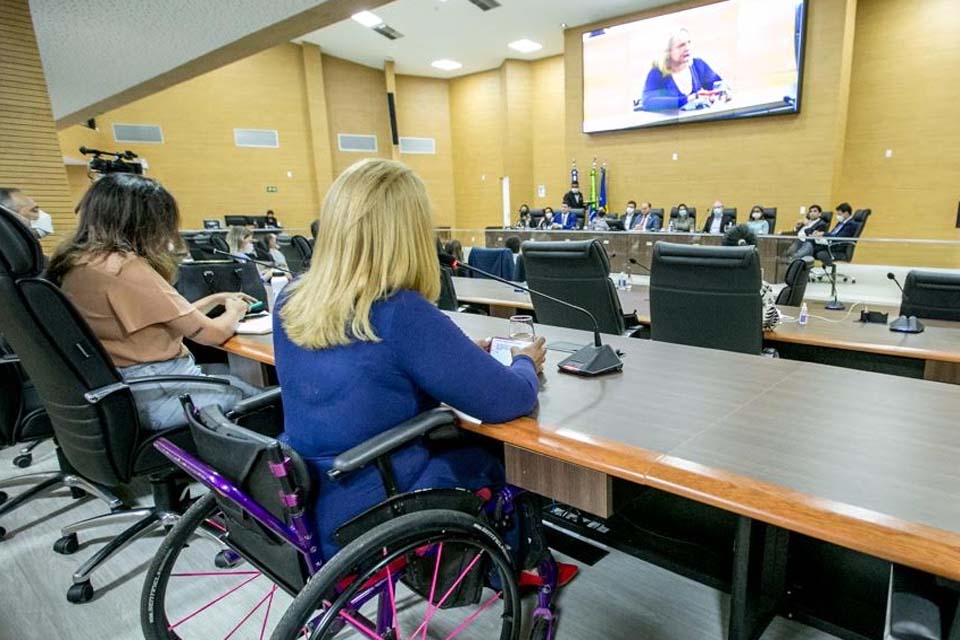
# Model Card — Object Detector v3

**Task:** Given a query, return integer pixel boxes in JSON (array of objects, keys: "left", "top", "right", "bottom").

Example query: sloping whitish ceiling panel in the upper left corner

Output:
[{"left": 30, "top": 0, "right": 332, "bottom": 119}]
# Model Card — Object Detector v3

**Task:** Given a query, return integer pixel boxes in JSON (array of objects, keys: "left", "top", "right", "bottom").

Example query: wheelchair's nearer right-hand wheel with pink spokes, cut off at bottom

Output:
[{"left": 272, "top": 509, "right": 521, "bottom": 640}]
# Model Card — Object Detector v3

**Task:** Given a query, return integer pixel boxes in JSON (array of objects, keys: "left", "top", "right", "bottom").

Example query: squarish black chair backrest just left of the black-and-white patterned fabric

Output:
[{"left": 650, "top": 242, "right": 763, "bottom": 354}]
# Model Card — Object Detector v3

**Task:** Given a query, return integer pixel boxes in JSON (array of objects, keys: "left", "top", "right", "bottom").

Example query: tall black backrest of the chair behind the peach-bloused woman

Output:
[{"left": 0, "top": 207, "right": 140, "bottom": 486}]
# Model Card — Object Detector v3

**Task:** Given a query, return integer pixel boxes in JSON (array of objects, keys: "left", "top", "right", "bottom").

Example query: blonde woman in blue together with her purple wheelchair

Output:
[{"left": 141, "top": 160, "right": 575, "bottom": 640}]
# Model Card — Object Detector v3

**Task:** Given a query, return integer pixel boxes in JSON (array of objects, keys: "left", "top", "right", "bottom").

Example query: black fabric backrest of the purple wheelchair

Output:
[{"left": 186, "top": 402, "right": 313, "bottom": 593}]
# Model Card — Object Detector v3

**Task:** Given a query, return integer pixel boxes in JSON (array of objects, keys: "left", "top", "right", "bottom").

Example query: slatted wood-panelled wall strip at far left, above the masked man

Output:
[{"left": 0, "top": 0, "right": 73, "bottom": 253}]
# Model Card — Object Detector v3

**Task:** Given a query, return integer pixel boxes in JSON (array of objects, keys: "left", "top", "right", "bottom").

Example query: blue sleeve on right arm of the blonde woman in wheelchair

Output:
[{"left": 389, "top": 291, "right": 540, "bottom": 423}]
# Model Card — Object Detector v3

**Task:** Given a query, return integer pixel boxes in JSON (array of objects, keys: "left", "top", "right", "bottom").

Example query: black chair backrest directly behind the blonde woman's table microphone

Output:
[{"left": 523, "top": 240, "right": 628, "bottom": 335}]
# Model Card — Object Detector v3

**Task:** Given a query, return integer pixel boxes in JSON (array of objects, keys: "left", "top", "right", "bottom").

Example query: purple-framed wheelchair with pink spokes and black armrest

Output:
[{"left": 140, "top": 396, "right": 560, "bottom": 640}]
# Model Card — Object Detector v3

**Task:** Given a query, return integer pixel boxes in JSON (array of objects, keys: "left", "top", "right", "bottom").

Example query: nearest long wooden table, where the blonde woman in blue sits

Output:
[{"left": 224, "top": 314, "right": 960, "bottom": 638}]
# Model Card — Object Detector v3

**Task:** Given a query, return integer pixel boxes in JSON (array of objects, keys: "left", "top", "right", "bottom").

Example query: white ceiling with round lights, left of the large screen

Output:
[{"left": 301, "top": 0, "right": 676, "bottom": 78}]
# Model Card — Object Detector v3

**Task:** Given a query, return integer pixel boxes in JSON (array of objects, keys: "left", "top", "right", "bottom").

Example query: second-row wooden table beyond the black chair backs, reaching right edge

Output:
[{"left": 453, "top": 278, "right": 960, "bottom": 384}]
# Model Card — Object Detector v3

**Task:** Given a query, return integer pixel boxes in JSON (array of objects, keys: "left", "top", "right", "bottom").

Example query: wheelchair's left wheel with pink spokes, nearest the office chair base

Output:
[{"left": 140, "top": 493, "right": 292, "bottom": 640}]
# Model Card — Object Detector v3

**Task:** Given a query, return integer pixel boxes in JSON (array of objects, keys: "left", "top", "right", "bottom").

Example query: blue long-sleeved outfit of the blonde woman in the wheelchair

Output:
[{"left": 273, "top": 291, "right": 539, "bottom": 559}]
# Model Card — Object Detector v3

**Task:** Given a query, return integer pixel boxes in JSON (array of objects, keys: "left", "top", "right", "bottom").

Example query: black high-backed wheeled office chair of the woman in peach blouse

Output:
[{"left": 0, "top": 207, "right": 279, "bottom": 603}]
